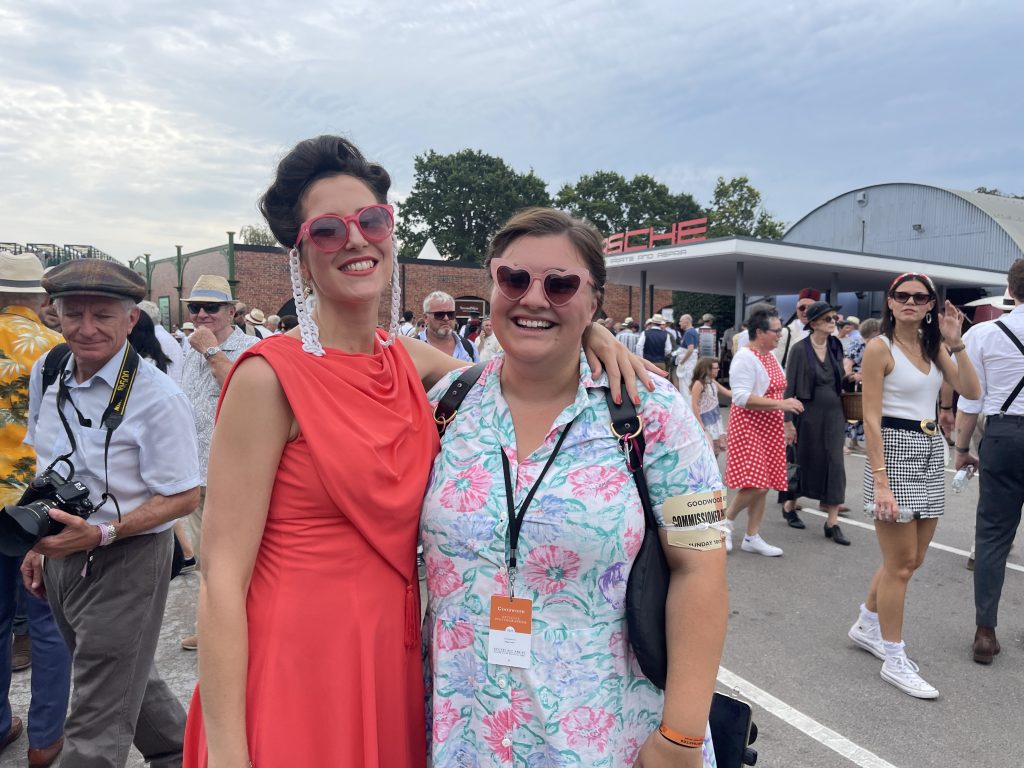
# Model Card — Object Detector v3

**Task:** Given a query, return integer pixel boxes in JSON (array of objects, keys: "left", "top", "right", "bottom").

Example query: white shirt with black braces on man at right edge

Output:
[{"left": 957, "top": 304, "right": 1024, "bottom": 416}]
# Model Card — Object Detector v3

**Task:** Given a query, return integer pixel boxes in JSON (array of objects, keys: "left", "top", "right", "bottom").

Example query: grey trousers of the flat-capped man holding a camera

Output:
[{"left": 43, "top": 530, "right": 185, "bottom": 768}]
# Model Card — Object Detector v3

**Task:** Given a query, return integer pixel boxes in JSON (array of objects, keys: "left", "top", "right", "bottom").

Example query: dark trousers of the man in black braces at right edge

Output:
[{"left": 974, "top": 416, "right": 1024, "bottom": 627}]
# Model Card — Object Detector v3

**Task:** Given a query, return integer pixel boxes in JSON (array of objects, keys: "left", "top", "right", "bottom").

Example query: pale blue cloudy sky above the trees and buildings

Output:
[{"left": 0, "top": 0, "right": 1024, "bottom": 261}]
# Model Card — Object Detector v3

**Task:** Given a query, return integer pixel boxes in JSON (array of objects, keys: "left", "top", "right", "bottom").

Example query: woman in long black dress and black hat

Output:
[{"left": 785, "top": 301, "right": 850, "bottom": 546}]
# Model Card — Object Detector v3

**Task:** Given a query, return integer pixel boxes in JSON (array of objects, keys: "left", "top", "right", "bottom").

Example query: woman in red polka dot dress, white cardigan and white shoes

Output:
[{"left": 725, "top": 304, "right": 804, "bottom": 557}]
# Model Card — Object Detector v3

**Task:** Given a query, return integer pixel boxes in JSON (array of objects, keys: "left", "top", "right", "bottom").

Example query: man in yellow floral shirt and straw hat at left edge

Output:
[{"left": 0, "top": 250, "right": 71, "bottom": 766}]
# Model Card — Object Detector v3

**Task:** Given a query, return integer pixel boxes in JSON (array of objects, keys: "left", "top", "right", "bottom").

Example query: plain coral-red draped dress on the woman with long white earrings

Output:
[{"left": 184, "top": 336, "right": 438, "bottom": 768}]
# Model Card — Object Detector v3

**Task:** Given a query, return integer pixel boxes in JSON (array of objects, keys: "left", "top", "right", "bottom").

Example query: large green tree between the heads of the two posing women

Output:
[{"left": 395, "top": 150, "right": 551, "bottom": 263}]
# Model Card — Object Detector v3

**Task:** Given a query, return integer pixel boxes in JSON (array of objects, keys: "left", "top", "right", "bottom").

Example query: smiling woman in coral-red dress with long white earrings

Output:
[{"left": 184, "top": 136, "right": 646, "bottom": 768}]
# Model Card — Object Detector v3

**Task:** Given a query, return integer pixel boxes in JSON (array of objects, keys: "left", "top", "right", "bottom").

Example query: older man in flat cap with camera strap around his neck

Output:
[{"left": 22, "top": 259, "right": 199, "bottom": 768}]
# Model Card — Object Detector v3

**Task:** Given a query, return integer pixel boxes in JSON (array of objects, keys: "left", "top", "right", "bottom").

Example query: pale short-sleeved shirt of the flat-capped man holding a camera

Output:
[{"left": 25, "top": 343, "right": 200, "bottom": 534}]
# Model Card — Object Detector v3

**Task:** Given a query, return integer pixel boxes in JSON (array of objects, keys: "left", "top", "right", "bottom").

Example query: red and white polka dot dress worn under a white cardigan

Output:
[{"left": 725, "top": 349, "right": 787, "bottom": 490}]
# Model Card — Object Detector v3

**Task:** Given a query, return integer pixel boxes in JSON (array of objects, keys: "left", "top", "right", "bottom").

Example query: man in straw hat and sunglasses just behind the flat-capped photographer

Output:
[{"left": 181, "top": 274, "right": 256, "bottom": 650}]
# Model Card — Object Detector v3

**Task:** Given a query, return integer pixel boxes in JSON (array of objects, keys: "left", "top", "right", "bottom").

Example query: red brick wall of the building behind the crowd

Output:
[{"left": 142, "top": 245, "right": 672, "bottom": 325}]
